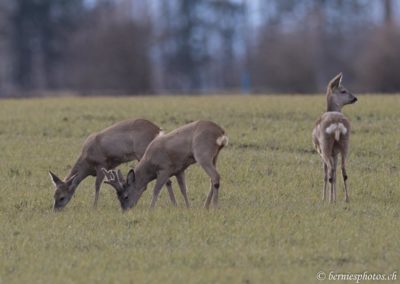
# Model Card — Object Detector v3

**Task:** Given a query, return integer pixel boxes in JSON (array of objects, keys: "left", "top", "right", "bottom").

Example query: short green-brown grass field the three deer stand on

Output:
[{"left": 0, "top": 95, "right": 400, "bottom": 284}]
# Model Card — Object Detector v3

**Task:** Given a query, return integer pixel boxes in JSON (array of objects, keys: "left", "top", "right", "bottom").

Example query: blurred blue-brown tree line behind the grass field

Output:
[{"left": 0, "top": 0, "right": 400, "bottom": 96}]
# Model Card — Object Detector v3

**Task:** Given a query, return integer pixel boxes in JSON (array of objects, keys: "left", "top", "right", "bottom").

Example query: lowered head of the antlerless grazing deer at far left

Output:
[{"left": 49, "top": 171, "right": 77, "bottom": 211}]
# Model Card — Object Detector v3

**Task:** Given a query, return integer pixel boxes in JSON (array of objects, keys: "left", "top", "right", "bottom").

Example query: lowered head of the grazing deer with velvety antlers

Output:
[{"left": 102, "top": 168, "right": 144, "bottom": 210}]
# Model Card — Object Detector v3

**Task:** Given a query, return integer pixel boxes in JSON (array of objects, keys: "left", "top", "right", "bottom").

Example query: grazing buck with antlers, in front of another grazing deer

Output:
[{"left": 104, "top": 121, "right": 228, "bottom": 210}]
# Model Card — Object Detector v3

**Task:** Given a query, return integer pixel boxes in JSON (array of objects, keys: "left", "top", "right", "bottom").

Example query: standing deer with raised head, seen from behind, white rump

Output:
[{"left": 312, "top": 73, "right": 357, "bottom": 202}]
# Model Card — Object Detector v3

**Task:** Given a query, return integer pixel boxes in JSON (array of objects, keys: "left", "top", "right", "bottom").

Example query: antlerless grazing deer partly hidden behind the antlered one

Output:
[{"left": 49, "top": 119, "right": 176, "bottom": 210}]
